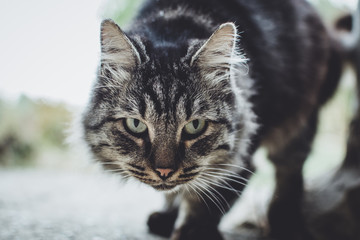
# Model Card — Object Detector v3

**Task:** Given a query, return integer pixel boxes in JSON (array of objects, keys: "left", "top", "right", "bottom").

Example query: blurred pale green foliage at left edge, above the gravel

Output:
[{"left": 0, "top": 96, "right": 71, "bottom": 166}]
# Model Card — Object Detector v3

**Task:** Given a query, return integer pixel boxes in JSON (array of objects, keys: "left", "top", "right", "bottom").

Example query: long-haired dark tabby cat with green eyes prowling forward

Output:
[{"left": 82, "top": 0, "right": 356, "bottom": 240}]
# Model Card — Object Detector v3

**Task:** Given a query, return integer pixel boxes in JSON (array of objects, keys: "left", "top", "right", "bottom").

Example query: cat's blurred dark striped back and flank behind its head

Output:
[{"left": 132, "top": 0, "right": 331, "bottom": 139}]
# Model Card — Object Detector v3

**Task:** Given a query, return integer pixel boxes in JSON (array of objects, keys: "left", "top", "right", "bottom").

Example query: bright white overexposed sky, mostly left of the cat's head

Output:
[{"left": 0, "top": 0, "right": 357, "bottom": 105}]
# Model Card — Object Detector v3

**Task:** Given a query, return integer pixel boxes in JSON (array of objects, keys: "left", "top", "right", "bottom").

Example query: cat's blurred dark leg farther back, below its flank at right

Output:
[{"left": 268, "top": 112, "right": 318, "bottom": 240}]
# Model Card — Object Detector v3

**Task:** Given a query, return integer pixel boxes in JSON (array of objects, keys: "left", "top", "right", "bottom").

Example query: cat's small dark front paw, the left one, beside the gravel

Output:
[{"left": 147, "top": 212, "right": 177, "bottom": 237}]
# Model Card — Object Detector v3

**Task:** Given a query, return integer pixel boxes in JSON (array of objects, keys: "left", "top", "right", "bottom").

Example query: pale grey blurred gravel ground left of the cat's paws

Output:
[{"left": 0, "top": 169, "right": 266, "bottom": 240}]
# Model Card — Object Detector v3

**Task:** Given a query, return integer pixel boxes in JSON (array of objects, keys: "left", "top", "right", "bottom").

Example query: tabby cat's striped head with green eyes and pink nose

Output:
[{"left": 83, "top": 20, "right": 255, "bottom": 190}]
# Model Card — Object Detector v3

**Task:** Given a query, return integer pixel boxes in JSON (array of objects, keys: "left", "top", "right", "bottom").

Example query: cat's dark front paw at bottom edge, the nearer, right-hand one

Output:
[{"left": 171, "top": 223, "right": 224, "bottom": 240}]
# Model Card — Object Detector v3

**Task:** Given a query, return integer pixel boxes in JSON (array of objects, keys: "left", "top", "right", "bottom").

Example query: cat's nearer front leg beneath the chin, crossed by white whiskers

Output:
[{"left": 171, "top": 159, "right": 255, "bottom": 240}]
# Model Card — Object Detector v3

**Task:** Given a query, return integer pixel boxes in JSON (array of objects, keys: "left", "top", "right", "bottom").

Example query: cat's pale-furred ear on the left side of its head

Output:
[{"left": 101, "top": 19, "right": 141, "bottom": 70}]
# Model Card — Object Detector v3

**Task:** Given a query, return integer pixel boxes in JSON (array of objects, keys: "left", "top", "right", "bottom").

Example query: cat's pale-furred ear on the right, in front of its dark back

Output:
[{"left": 190, "top": 23, "right": 239, "bottom": 84}]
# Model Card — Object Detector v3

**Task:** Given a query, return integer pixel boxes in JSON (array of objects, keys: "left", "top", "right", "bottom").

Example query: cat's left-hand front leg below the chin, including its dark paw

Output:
[{"left": 147, "top": 193, "right": 179, "bottom": 237}]
